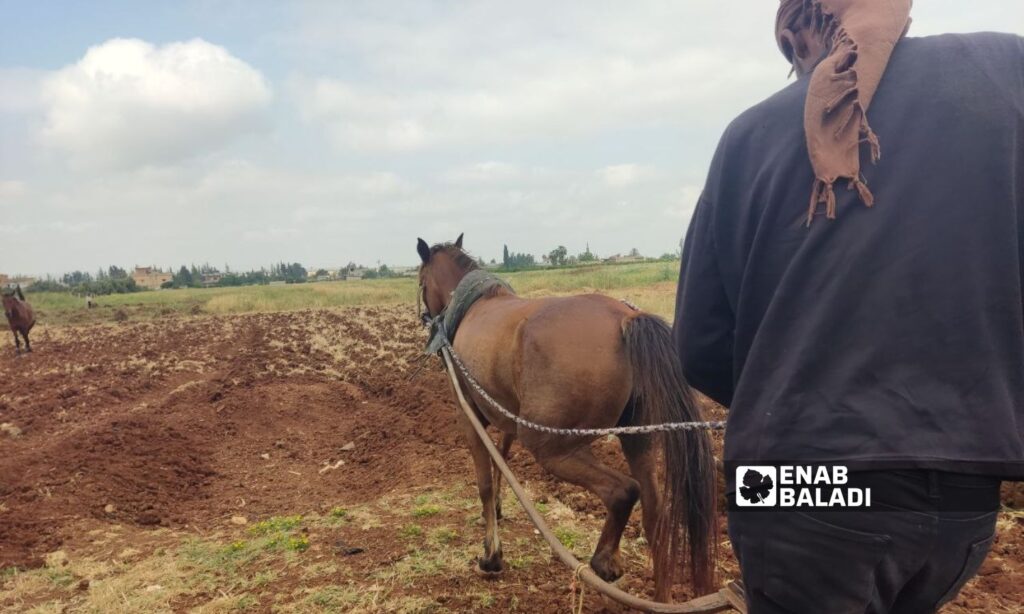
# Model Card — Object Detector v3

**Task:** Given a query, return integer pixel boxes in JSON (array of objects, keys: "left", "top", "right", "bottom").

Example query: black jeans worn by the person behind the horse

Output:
[{"left": 729, "top": 471, "right": 999, "bottom": 614}]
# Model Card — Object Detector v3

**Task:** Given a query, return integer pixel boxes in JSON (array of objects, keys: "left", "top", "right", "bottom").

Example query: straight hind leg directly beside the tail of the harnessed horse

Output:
[{"left": 618, "top": 435, "right": 675, "bottom": 602}]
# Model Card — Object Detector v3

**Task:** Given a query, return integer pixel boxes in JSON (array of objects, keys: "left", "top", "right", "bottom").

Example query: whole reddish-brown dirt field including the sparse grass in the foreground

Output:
[{"left": 0, "top": 307, "right": 1024, "bottom": 613}]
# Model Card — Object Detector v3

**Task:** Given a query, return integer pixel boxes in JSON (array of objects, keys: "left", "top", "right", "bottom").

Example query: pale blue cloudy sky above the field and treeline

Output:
[{"left": 0, "top": 0, "right": 1024, "bottom": 275}]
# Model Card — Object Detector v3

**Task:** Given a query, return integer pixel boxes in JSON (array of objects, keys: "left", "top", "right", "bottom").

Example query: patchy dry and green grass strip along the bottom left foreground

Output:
[{"left": 0, "top": 483, "right": 596, "bottom": 614}]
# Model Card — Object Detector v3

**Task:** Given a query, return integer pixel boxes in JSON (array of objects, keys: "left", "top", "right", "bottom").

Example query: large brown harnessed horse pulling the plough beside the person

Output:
[{"left": 417, "top": 234, "right": 717, "bottom": 601}]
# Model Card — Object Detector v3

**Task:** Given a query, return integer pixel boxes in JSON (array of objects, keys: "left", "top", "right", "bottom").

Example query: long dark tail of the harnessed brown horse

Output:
[{"left": 623, "top": 313, "right": 718, "bottom": 594}]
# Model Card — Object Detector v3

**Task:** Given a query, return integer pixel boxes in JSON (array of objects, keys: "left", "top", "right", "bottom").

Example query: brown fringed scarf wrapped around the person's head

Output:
[{"left": 775, "top": 0, "right": 913, "bottom": 224}]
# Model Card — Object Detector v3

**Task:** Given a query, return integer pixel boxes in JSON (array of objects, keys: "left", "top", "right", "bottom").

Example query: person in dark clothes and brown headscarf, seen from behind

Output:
[{"left": 675, "top": 0, "right": 1024, "bottom": 614}]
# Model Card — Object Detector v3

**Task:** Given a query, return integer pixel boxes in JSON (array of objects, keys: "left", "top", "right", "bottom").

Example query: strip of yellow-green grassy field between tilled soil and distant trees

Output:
[{"left": 27, "top": 262, "right": 679, "bottom": 325}]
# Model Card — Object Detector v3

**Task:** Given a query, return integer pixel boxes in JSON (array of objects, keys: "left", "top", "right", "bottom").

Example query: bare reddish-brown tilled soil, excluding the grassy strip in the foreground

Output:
[{"left": 0, "top": 307, "right": 1024, "bottom": 612}]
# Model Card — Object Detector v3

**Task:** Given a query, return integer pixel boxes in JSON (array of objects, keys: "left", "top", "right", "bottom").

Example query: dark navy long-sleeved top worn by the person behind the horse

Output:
[{"left": 675, "top": 34, "right": 1024, "bottom": 478}]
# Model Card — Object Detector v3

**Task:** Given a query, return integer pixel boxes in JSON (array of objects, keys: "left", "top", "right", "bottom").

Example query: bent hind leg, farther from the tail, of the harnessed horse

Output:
[{"left": 537, "top": 444, "right": 640, "bottom": 582}]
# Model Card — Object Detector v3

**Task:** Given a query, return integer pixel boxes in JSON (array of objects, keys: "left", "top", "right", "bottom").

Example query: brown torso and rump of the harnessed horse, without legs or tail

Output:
[{"left": 455, "top": 295, "right": 635, "bottom": 435}]
